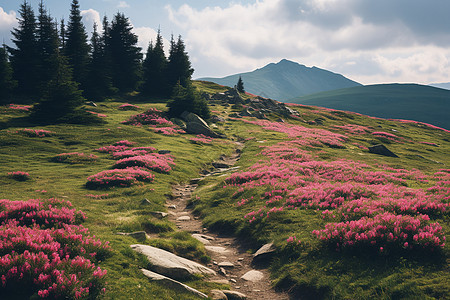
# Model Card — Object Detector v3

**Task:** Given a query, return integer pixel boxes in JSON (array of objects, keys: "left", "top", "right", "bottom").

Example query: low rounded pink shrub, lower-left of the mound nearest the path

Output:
[{"left": 86, "top": 168, "right": 155, "bottom": 189}]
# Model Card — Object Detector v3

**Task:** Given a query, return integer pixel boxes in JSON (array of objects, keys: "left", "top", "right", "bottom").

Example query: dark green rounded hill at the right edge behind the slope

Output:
[{"left": 289, "top": 84, "right": 450, "bottom": 129}]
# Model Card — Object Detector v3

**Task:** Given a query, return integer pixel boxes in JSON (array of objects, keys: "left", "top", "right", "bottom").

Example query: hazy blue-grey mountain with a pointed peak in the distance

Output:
[{"left": 198, "top": 59, "right": 361, "bottom": 102}]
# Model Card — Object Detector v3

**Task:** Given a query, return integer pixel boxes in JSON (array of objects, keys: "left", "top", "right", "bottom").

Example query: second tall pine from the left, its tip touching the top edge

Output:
[{"left": 37, "top": 0, "right": 59, "bottom": 93}]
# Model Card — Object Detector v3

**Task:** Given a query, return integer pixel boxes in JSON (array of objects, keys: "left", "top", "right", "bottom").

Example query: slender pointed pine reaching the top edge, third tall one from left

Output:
[{"left": 64, "top": 0, "right": 89, "bottom": 88}]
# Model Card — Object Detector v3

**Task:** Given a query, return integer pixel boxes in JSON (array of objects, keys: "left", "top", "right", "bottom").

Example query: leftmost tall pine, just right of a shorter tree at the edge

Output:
[{"left": 8, "top": 0, "right": 39, "bottom": 97}]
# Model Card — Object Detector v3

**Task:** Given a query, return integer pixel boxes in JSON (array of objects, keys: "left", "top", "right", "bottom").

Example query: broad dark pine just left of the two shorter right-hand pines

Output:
[{"left": 107, "top": 13, "right": 142, "bottom": 92}]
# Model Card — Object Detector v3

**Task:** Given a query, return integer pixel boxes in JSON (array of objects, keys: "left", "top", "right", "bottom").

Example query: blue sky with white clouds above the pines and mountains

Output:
[{"left": 0, "top": 0, "right": 450, "bottom": 84}]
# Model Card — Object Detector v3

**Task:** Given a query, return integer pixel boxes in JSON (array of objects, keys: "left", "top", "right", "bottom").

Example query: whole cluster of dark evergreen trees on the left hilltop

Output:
[{"left": 0, "top": 0, "right": 209, "bottom": 121}]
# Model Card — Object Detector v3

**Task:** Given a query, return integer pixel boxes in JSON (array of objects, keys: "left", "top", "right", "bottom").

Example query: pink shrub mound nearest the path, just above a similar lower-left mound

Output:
[{"left": 113, "top": 153, "right": 175, "bottom": 173}]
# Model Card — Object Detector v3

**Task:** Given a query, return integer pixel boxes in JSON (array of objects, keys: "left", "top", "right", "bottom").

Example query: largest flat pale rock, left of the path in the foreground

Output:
[{"left": 130, "top": 244, "right": 216, "bottom": 280}]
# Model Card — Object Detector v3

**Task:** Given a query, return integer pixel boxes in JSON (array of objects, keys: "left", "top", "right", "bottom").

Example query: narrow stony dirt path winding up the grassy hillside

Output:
[{"left": 167, "top": 143, "right": 289, "bottom": 300}]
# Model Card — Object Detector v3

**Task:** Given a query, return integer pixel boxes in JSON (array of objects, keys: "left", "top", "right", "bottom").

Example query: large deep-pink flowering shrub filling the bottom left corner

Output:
[{"left": 0, "top": 199, "right": 110, "bottom": 299}]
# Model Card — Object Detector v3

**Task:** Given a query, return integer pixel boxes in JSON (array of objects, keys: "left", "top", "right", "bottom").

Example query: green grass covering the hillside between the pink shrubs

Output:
[{"left": 0, "top": 82, "right": 450, "bottom": 299}]
